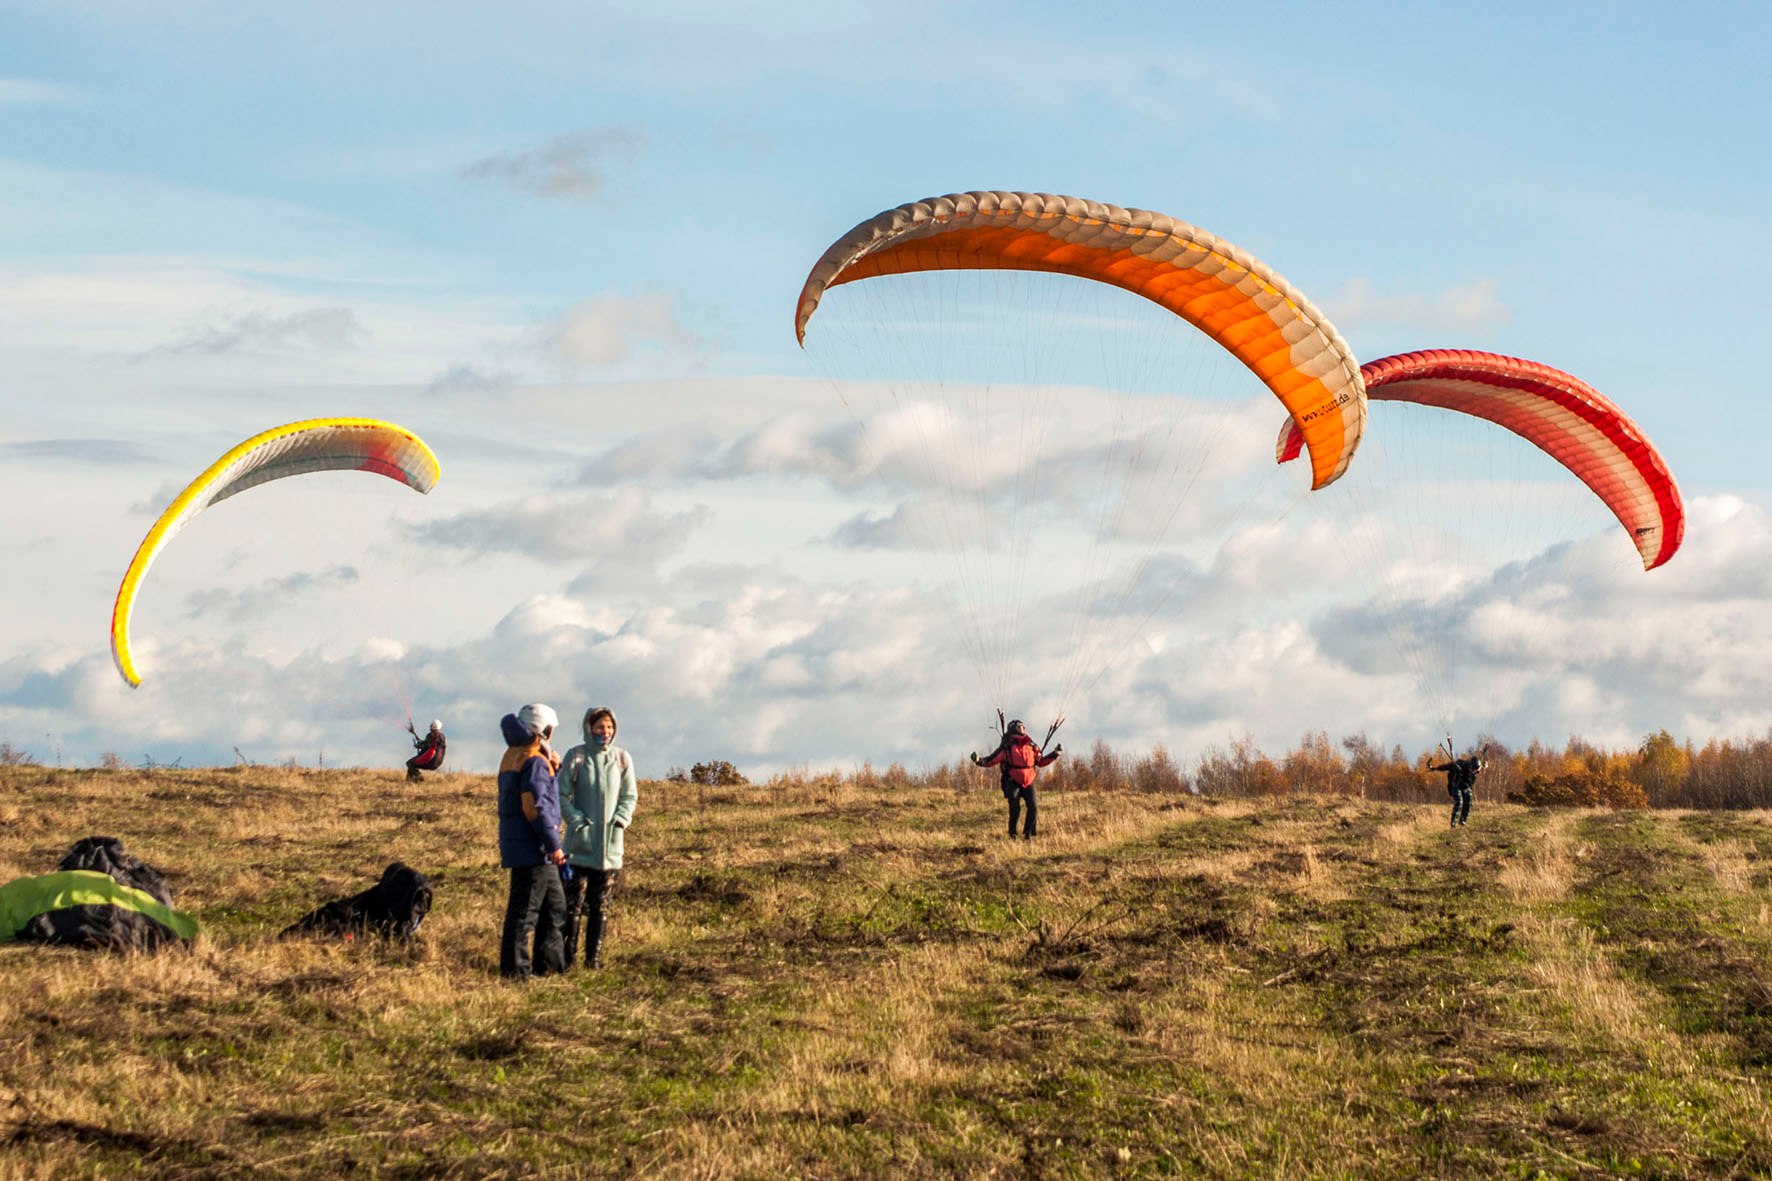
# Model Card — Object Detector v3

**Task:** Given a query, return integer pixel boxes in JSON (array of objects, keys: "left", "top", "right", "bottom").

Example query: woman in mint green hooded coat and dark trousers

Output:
[{"left": 560, "top": 706, "right": 640, "bottom": 968}]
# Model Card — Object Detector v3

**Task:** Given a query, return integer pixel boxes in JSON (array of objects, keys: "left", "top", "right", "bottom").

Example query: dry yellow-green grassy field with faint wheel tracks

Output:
[{"left": 0, "top": 768, "right": 1772, "bottom": 1177}]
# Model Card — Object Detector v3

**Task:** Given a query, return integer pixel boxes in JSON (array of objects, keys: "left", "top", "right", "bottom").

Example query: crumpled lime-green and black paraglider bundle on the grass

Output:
[{"left": 0, "top": 837, "right": 197, "bottom": 952}]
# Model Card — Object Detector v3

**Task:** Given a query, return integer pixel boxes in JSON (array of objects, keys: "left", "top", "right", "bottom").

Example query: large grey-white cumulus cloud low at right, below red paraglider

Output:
[{"left": 1313, "top": 498, "right": 1772, "bottom": 743}]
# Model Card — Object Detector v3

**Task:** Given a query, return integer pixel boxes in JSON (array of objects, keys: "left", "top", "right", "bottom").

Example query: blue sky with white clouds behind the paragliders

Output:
[{"left": 0, "top": 0, "right": 1772, "bottom": 777}]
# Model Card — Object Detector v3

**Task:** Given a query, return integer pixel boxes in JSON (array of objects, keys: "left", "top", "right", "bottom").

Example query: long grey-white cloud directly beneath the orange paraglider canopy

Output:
[{"left": 579, "top": 395, "right": 1302, "bottom": 550}]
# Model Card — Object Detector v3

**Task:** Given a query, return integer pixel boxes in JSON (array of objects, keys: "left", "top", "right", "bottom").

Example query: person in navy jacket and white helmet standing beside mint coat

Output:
[{"left": 498, "top": 704, "right": 565, "bottom": 979}]
